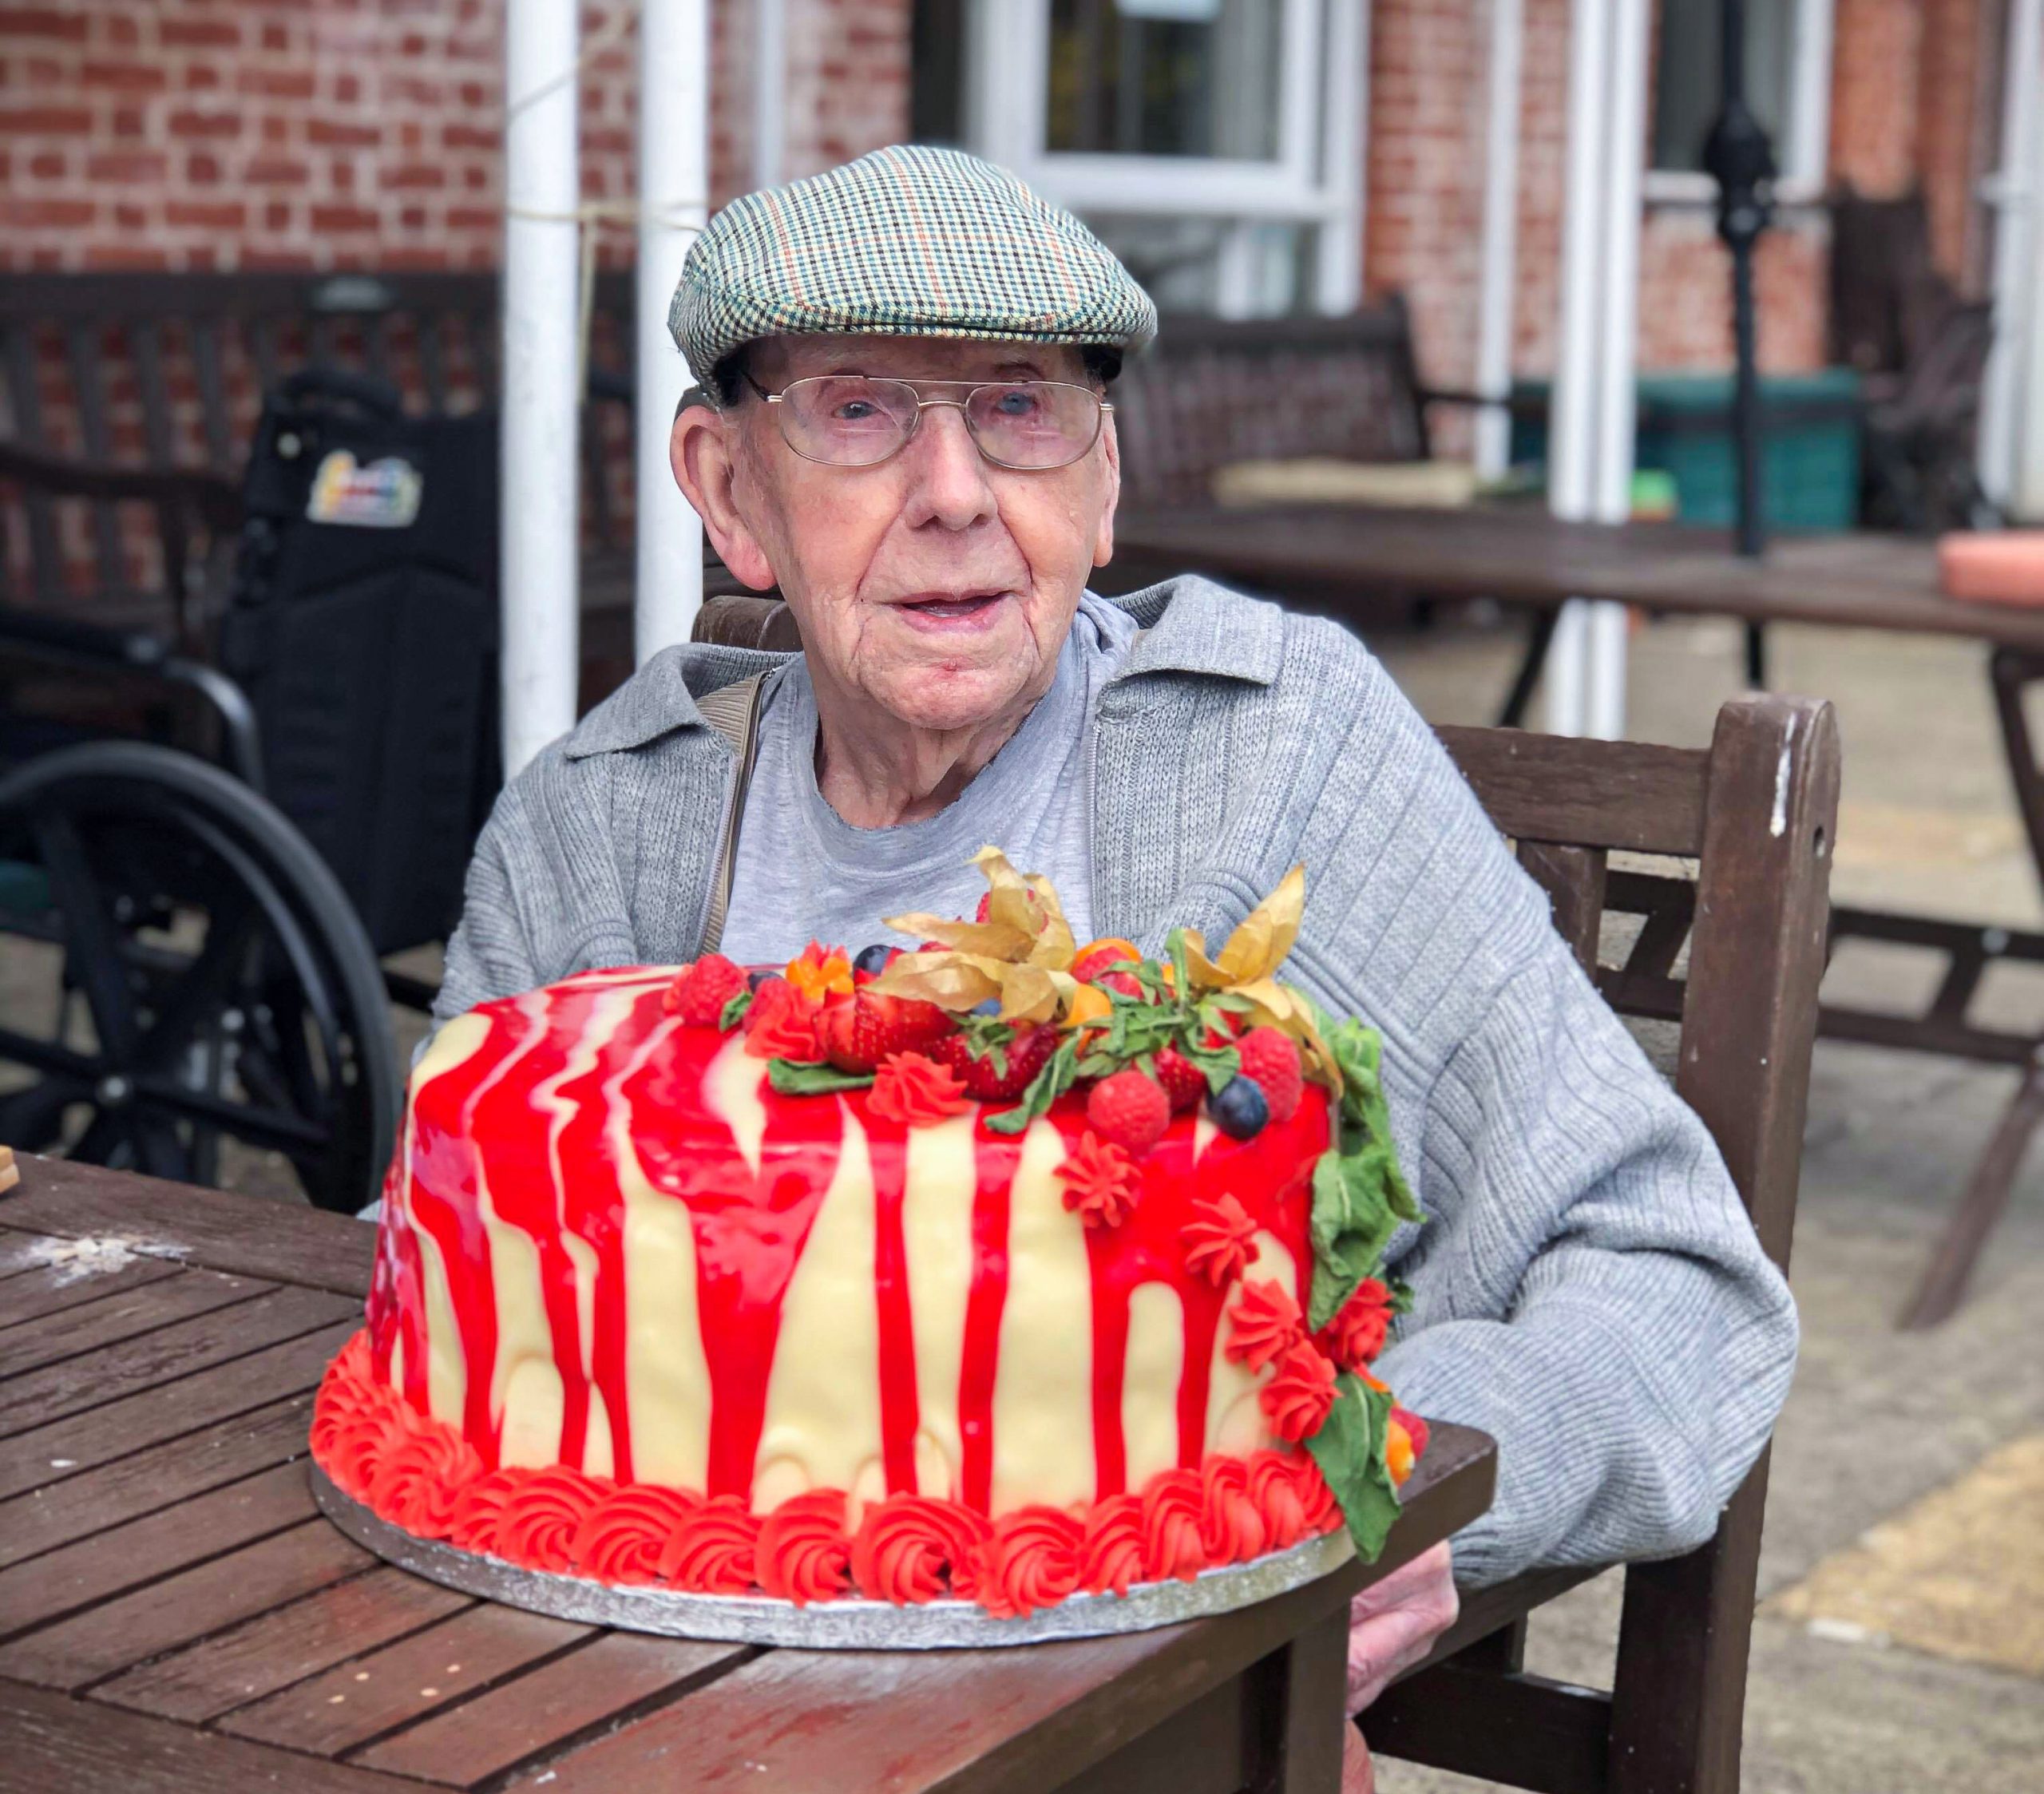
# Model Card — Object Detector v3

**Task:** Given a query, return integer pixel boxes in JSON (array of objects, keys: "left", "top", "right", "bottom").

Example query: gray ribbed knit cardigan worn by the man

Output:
[{"left": 438, "top": 578, "right": 1796, "bottom": 1583}]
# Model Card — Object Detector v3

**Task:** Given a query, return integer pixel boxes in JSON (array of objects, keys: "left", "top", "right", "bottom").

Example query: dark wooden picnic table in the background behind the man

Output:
[{"left": 1102, "top": 505, "right": 2044, "bottom": 1326}]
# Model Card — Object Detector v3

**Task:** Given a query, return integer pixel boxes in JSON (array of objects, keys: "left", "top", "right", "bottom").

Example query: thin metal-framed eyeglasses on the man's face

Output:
[{"left": 746, "top": 374, "right": 1114, "bottom": 474}]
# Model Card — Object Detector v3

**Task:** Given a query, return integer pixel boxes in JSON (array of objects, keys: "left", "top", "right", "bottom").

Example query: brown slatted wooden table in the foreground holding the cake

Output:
[{"left": 0, "top": 1158, "right": 1496, "bottom": 1794}]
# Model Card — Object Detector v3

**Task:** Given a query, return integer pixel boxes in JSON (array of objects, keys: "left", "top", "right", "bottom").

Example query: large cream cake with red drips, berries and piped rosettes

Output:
[{"left": 313, "top": 848, "right": 1424, "bottom": 1616}]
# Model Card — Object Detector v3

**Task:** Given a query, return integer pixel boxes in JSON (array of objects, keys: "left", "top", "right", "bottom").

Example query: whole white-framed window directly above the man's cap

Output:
[{"left": 965, "top": 0, "right": 1365, "bottom": 317}]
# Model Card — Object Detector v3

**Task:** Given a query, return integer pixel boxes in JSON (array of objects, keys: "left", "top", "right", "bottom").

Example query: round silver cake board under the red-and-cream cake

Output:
[{"left": 313, "top": 1463, "right": 1355, "bottom": 1651}]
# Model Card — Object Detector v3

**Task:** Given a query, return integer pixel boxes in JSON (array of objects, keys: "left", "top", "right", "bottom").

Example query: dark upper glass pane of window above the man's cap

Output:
[{"left": 1044, "top": 0, "right": 1284, "bottom": 161}]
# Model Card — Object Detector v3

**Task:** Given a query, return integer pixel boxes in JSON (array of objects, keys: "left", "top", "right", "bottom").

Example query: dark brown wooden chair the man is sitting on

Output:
[{"left": 1364, "top": 697, "right": 1840, "bottom": 1794}]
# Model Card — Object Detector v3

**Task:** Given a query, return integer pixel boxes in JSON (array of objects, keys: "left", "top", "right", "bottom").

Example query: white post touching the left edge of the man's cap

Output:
[{"left": 632, "top": 0, "right": 709, "bottom": 666}]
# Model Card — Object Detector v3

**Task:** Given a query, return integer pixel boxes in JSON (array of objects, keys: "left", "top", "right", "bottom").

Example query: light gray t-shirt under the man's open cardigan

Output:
[{"left": 719, "top": 592, "right": 1136, "bottom": 964}]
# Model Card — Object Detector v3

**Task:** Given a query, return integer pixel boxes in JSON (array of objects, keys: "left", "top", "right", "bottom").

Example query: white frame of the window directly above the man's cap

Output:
[{"left": 965, "top": 0, "right": 1368, "bottom": 315}]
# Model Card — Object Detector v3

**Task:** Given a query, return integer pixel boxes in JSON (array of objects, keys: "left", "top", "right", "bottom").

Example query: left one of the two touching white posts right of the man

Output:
[{"left": 1545, "top": 0, "right": 1610, "bottom": 735}]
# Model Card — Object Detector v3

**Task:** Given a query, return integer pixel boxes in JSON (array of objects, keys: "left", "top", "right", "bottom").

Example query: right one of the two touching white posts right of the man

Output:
[{"left": 1584, "top": 0, "right": 1650, "bottom": 742}]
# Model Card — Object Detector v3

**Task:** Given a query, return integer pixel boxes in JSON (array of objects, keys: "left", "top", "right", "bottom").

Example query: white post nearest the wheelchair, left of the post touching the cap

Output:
[{"left": 499, "top": 0, "right": 580, "bottom": 778}]
